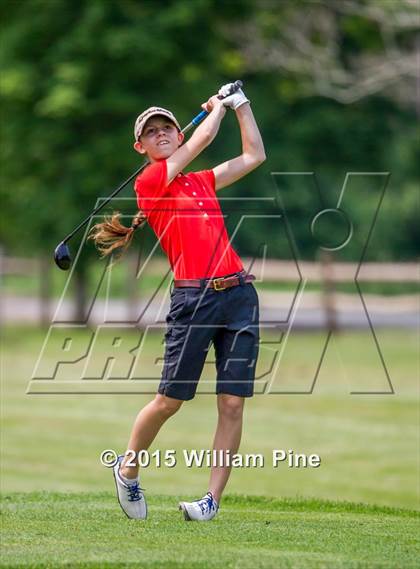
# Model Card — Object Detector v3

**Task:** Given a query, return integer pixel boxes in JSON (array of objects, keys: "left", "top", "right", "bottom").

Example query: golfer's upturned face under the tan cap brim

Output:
[{"left": 140, "top": 117, "right": 183, "bottom": 160}]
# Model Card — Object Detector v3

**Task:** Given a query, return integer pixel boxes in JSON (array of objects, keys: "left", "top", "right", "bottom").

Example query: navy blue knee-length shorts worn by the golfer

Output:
[{"left": 158, "top": 273, "right": 259, "bottom": 401}]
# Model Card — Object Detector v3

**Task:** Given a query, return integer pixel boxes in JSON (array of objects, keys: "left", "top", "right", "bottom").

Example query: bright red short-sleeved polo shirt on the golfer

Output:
[{"left": 134, "top": 160, "right": 243, "bottom": 279}]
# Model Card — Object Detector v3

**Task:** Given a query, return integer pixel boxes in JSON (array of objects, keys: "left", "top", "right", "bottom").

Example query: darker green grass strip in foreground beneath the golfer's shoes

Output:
[{"left": 1, "top": 492, "right": 420, "bottom": 569}]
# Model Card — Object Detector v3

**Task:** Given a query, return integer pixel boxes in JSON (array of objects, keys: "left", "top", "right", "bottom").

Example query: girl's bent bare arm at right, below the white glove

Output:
[{"left": 213, "top": 103, "right": 265, "bottom": 190}]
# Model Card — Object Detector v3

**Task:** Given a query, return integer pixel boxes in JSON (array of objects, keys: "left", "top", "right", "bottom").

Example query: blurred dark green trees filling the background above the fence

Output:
[{"left": 0, "top": 0, "right": 419, "bottom": 270}]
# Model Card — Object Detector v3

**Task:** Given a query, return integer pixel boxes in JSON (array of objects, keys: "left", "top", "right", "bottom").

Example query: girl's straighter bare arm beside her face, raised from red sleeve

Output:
[{"left": 166, "top": 95, "right": 226, "bottom": 184}]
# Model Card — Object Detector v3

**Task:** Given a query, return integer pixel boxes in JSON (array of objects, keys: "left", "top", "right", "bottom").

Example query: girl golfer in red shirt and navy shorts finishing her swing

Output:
[{"left": 92, "top": 84, "right": 265, "bottom": 521}]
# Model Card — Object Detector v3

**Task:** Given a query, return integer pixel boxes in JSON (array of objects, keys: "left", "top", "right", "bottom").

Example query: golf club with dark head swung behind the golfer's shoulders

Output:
[{"left": 54, "top": 80, "right": 243, "bottom": 271}]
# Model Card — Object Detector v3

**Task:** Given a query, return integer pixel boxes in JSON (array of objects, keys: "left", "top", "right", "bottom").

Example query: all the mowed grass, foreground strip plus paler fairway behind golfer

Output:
[{"left": 1, "top": 329, "right": 420, "bottom": 569}]
